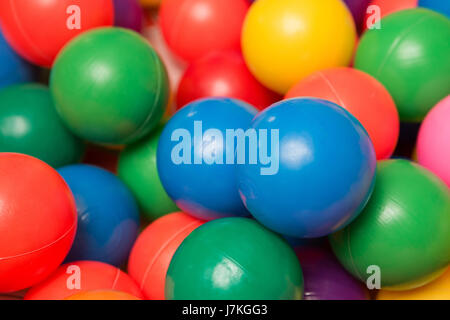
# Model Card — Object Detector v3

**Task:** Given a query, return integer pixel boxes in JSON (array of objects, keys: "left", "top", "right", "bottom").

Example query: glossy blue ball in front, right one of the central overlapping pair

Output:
[{"left": 237, "top": 98, "right": 376, "bottom": 238}]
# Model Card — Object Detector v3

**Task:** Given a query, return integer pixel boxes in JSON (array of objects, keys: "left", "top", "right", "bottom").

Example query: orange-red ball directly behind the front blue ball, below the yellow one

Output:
[{"left": 286, "top": 68, "right": 400, "bottom": 159}]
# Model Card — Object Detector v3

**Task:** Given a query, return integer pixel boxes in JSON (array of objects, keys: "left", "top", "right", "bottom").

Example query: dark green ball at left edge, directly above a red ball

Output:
[{"left": 0, "top": 84, "right": 84, "bottom": 168}]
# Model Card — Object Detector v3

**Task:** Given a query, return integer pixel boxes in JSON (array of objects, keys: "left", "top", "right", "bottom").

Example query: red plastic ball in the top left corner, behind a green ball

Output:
[{"left": 0, "top": 0, "right": 114, "bottom": 67}]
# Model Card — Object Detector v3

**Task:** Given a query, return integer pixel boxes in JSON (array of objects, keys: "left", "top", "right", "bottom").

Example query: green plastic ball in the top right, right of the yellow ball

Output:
[{"left": 355, "top": 9, "right": 450, "bottom": 122}]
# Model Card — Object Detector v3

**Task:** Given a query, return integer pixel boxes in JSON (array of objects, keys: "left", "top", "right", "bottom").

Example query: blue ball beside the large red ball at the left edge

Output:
[{"left": 58, "top": 164, "right": 139, "bottom": 266}]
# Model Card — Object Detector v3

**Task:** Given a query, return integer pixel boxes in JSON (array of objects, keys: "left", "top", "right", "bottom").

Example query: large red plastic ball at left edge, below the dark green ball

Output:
[{"left": 0, "top": 153, "right": 77, "bottom": 292}]
